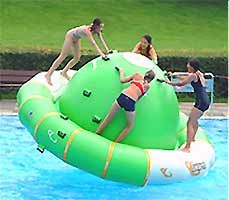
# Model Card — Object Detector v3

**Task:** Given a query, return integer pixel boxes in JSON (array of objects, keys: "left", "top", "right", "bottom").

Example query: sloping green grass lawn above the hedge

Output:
[{"left": 0, "top": 0, "right": 227, "bottom": 56}]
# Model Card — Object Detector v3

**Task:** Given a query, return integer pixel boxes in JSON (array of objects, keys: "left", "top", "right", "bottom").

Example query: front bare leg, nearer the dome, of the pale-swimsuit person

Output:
[{"left": 61, "top": 39, "right": 81, "bottom": 80}]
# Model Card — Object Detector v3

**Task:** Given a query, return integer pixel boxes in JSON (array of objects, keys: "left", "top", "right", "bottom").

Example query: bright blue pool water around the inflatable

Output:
[{"left": 0, "top": 116, "right": 228, "bottom": 200}]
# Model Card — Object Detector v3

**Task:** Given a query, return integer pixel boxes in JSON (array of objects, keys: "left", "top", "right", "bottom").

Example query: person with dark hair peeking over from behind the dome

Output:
[{"left": 132, "top": 35, "right": 158, "bottom": 64}]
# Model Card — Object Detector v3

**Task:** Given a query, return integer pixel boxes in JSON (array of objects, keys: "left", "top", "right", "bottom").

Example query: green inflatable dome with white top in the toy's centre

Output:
[{"left": 58, "top": 53, "right": 179, "bottom": 149}]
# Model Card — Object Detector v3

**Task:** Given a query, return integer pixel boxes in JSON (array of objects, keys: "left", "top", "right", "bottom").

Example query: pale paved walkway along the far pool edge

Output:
[{"left": 0, "top": 100, "right": 229, "bottom": 118}]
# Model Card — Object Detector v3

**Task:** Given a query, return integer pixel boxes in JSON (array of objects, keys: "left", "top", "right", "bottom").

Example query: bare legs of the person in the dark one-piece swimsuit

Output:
[{"left": 182, "top": 108, "right": 203, "bottom": 152}]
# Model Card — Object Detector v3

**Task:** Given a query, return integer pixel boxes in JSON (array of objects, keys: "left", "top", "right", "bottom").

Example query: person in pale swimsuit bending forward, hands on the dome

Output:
[{"left": 45, "top": 18, "right": 109, "bottom": 85}]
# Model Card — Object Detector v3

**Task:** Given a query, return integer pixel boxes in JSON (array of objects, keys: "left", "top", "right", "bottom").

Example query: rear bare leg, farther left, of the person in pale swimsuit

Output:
[{"left": 45, "top": 33, "right": 72, "bottom": 85}]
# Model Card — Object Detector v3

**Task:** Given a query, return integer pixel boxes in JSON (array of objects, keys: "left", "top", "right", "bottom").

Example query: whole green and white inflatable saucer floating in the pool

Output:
[{"left": 17, "top": 52, "right": 215, "bottom": 186}]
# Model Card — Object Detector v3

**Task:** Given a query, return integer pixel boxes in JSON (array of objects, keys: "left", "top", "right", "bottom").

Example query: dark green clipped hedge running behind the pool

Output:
[{"left": 0, "top": 52, "right": 228, "bottom": 97}]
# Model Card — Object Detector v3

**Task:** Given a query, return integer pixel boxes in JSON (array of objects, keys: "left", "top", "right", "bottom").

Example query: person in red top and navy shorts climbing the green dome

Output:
[{"left": 96, "top": 67, "right": 155, "bottom": 142}]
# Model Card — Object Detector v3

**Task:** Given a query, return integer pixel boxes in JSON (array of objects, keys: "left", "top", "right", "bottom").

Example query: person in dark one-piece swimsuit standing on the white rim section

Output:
[{"left": 165, "top": 59, "right": 210, "bottom": 152}]
